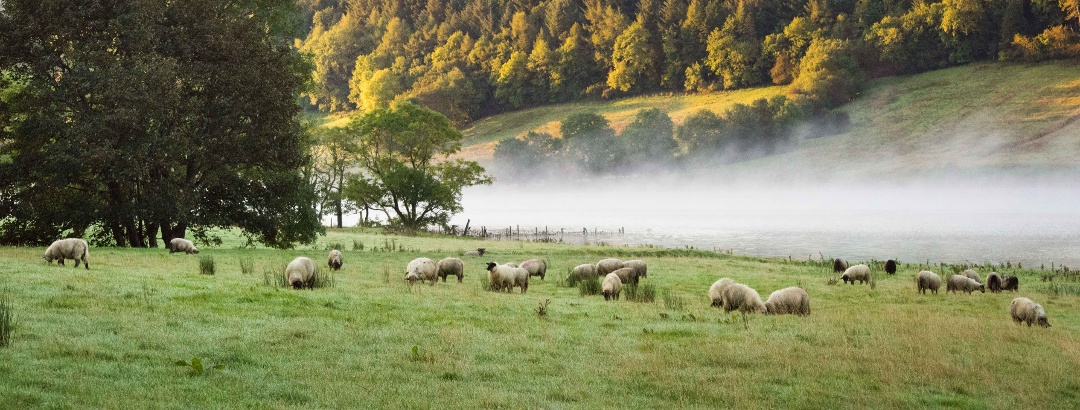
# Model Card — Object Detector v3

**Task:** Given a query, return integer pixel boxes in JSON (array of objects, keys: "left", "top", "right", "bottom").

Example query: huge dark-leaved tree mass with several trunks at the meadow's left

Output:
[{"left": 0, "top": 0, "right": 322, "bottom": 247}]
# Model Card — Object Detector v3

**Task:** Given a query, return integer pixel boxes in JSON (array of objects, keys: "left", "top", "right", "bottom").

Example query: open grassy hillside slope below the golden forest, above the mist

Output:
[{"left": 462, "top": 63, "right": 1080, "bottom": 176}]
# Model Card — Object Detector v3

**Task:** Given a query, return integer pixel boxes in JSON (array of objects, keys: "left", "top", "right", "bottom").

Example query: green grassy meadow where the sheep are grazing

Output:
[{"left": 0, "top": 229, "right": 1080, "bottom": 408}]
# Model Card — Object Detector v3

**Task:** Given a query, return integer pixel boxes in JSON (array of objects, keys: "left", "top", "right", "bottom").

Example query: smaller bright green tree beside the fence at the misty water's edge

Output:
[{"left": 345, "top": 101, "right": 491, "bottom": 230}]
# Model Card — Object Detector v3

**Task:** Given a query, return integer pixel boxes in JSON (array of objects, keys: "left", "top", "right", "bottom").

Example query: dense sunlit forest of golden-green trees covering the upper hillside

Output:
[{"left": 296, "top": 0, "right": 1080, "bottom": 126}]
